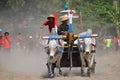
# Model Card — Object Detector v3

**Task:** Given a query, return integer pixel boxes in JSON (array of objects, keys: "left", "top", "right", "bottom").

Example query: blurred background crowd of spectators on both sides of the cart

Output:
[{"left": 0, "top": 31, "right": 120, "bottom": 53}]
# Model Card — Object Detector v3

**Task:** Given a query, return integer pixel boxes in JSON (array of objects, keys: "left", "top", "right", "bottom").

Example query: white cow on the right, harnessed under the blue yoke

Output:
[{"left": 74, "top": 32, "right": 96, "bottom": 76}]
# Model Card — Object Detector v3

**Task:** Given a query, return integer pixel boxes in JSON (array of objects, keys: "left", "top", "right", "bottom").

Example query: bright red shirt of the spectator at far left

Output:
[{"left": 2, "top": 36, "right": 12, "bottom": 49}]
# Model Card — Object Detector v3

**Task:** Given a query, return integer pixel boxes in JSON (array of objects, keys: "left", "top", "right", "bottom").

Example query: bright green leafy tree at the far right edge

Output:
[{"left": 106, "top": 0, "right": 120, "bottom": 36}]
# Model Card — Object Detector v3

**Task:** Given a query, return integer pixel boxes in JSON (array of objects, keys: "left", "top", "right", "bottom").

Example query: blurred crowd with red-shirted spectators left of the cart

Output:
[{"left": 0, "top": 31, "right": 40, "bottom": 53}]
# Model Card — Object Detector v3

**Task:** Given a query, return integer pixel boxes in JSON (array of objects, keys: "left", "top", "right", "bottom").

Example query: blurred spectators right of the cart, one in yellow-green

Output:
[{"left": 98, "top": 36, "right": 120, "bottom": 52}]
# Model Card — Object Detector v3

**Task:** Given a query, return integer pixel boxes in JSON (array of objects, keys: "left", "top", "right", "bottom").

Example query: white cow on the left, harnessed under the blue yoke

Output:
[{"left": 41, "top": 39, "right": 66, "bottom": 77}]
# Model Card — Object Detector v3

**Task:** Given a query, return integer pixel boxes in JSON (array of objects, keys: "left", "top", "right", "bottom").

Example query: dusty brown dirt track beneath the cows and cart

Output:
[{"left": 0, "top": 48, "right": 120, "bottom": 80}]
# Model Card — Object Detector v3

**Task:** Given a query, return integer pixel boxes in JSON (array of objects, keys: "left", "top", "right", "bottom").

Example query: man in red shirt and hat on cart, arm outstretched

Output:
[{"left": 41, "top": 14, "right": 55, "bottom": 34}]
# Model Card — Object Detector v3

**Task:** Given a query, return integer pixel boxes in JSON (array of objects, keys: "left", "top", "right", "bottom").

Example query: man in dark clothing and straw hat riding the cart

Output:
[{"left": 58, "top": 16, "right": 69, "bottom": 35}]
